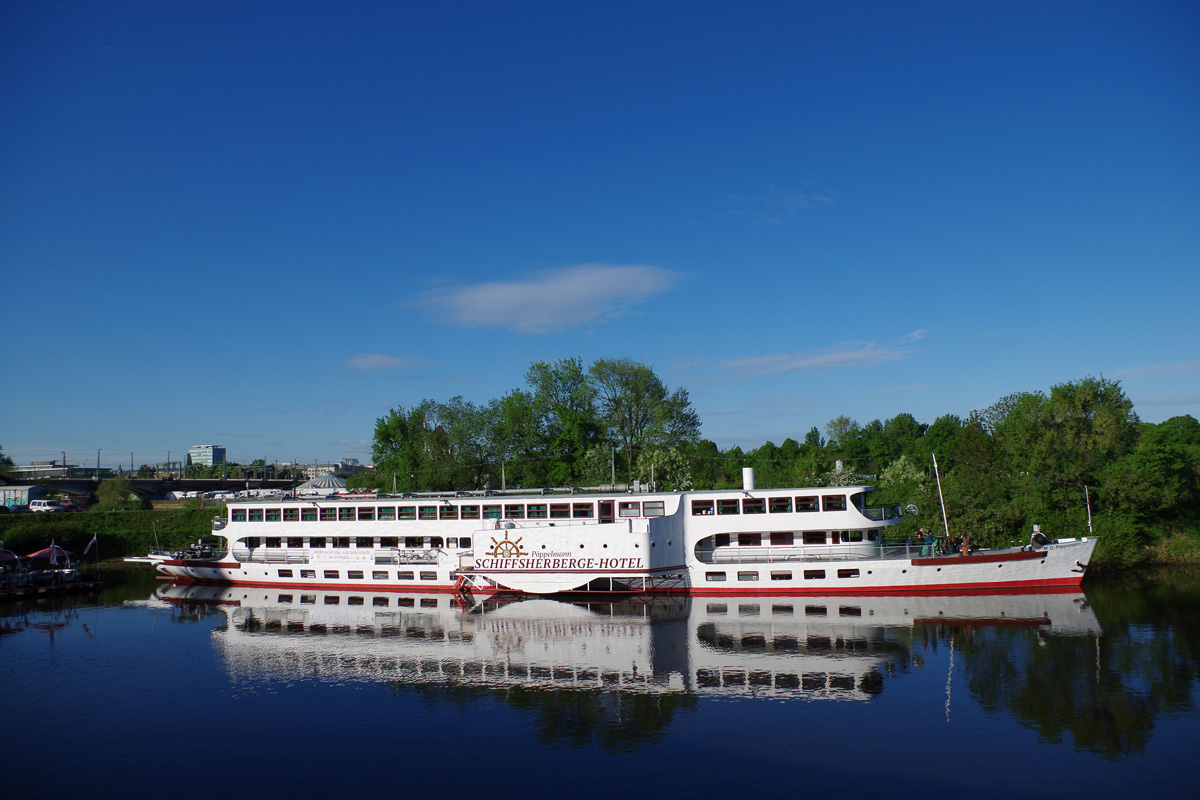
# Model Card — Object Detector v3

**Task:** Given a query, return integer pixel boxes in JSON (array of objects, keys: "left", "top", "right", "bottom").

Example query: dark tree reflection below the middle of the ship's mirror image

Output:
[{"left": 392, "top": 681, "right": 697, "bottom": 752}]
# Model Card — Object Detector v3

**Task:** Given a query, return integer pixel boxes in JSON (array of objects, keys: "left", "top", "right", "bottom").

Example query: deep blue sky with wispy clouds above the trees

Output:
[{"left": 0, "top": 0, "right": 1200, "bottom": 465}]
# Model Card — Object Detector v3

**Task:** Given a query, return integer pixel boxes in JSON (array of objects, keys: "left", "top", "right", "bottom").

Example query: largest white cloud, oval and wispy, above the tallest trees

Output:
[{"left": 421, "top": 264, "right": 680, "bottom": 333}]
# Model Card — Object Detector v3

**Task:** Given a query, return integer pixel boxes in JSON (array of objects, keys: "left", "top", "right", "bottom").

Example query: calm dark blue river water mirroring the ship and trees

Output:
[{"left": 0, "top": 571, "right": 1200, "bottom": 799}]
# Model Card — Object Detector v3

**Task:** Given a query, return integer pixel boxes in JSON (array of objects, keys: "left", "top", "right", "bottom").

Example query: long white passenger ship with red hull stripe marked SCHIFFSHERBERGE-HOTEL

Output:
[{"left": 157, "top": 469, "right": 1096, "bottom": 595}]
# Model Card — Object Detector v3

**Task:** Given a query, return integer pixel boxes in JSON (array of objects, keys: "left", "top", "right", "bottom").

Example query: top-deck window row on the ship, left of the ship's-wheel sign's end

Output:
[{"left": 229, "top": 500, "right": 666, "bottom": 522}]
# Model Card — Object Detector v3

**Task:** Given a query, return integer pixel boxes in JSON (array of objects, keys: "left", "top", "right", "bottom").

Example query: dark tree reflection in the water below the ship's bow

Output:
[{"left": 952, "top": 572, "right": 1200, "bottom": 759}]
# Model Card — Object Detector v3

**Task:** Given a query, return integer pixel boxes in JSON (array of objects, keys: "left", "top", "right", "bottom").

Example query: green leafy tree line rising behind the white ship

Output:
[{"left": 352, "top": 359, "right": 1200, "bottom": 564}]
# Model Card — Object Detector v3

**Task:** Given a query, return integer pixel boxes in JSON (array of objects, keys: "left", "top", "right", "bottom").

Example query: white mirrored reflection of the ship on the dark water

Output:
[{"left": 157, "top": 585, "right": 1099, "bottom": 699}]
